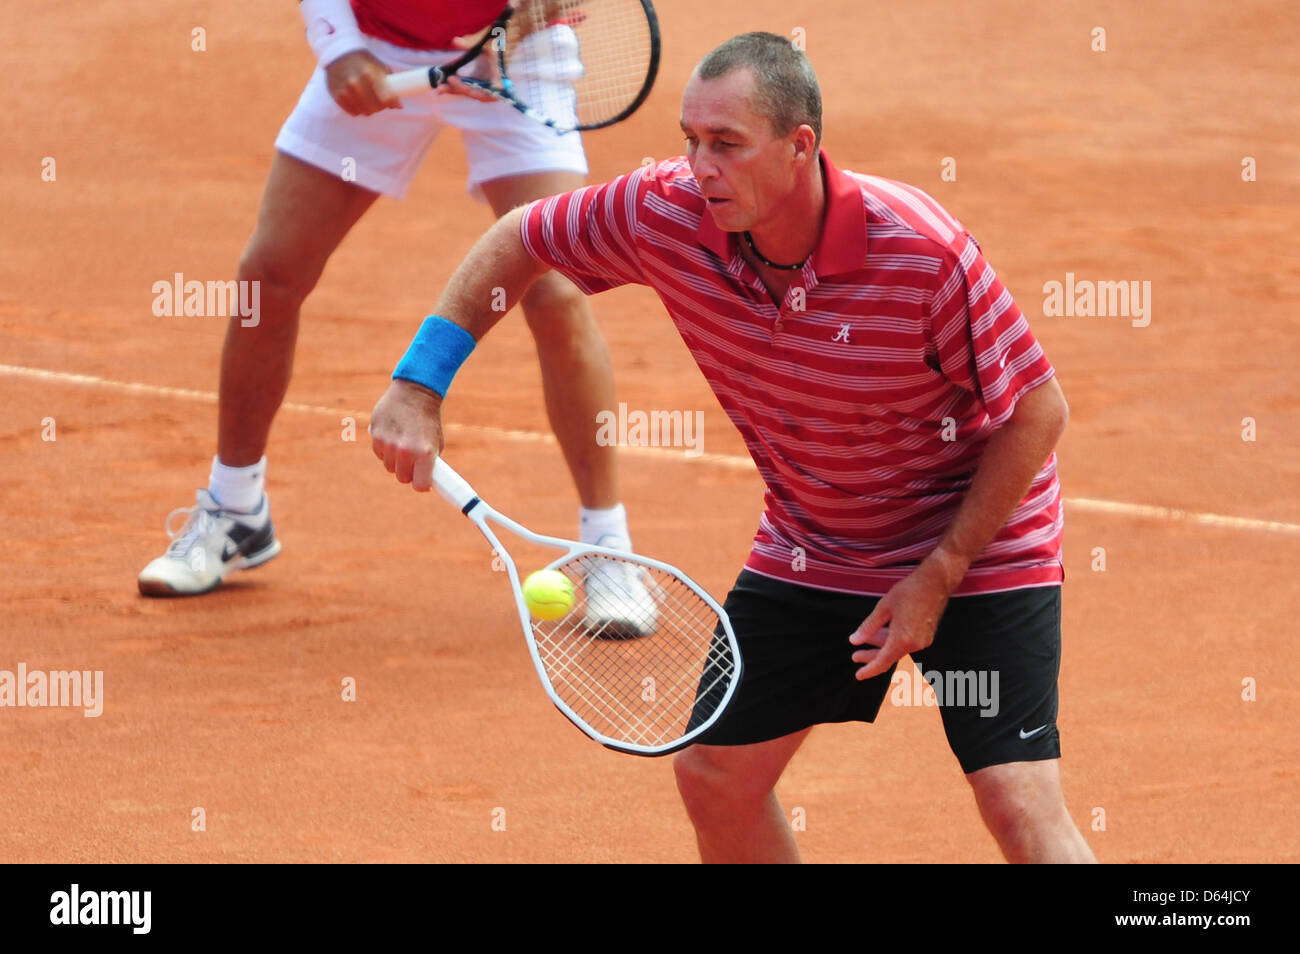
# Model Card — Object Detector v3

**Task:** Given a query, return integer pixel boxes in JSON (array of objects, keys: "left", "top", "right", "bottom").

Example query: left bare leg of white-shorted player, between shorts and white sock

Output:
[{"left": 217, "top": 152, "right": 378, "bottom": 467}]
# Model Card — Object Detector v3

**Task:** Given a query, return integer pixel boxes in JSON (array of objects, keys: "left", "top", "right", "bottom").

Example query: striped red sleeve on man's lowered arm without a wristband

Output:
[{"left": 930, "top": 233, "right": 1056, "bottom": 428}]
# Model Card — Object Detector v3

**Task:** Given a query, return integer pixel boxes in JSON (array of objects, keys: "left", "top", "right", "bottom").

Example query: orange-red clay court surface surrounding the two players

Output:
[{"left": 0, "top": 0, "right": 1300, "bottom": 863}]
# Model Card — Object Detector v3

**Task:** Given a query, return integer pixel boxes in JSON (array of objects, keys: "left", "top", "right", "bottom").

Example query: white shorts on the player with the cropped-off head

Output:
[{"left": 276, "top": 36, "right": 588, "bottom": 199}]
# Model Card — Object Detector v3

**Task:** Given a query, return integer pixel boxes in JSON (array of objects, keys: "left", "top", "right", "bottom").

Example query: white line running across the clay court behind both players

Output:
[{"left": 0, "top": 364, "right": 1300, "bottom": 534}]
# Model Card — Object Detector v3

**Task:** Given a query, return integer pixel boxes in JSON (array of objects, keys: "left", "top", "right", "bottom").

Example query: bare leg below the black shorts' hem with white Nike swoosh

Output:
[{"left": 966, "top": 759, "right": 1097, "bottom": 863}]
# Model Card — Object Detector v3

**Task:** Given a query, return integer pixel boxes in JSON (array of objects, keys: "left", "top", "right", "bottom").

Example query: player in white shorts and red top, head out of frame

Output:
[{"left": 139, "top": 0, "right": 653, "bottom": 626}]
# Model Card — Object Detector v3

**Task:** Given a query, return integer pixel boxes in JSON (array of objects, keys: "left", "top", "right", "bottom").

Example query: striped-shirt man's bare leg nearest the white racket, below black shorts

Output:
[{"left": 672, "top": 729, "right": 811, "bottom": 864}]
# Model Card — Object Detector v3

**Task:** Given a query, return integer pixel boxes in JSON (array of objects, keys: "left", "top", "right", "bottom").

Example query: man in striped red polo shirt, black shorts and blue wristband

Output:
[{"left": 371, "top": 34, "right": 1095, "bottom": 862}]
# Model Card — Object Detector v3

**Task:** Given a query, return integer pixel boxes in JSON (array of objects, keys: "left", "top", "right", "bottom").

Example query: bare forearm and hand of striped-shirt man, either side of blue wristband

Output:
[{"left": 371, "top": 209, "right": 547, "bottom": 491}]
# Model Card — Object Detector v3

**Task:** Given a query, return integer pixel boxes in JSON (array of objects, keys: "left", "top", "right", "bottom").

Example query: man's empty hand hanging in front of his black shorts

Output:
[{"left": 849, "top": 550, "right": 966, "bottom": 680}]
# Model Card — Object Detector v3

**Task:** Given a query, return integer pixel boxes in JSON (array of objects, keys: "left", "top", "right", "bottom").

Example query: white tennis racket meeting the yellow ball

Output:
[{"left": 433, "top": 459, "right": 741, "bottom": 755}]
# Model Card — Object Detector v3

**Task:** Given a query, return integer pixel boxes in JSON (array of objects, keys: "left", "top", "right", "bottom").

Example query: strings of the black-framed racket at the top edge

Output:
[{"left": 502, "top": 0, "right": 654, "bottom": 127}]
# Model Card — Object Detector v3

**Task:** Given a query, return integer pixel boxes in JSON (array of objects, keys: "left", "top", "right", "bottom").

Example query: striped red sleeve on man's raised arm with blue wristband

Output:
[{"left": 520, "top": 169, "right": 647, "bottom": 295}]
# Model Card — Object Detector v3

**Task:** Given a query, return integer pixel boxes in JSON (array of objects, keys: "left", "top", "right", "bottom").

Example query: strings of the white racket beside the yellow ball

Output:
[{"left": 533, "top": 555, "right": 737, "bottom": 746}]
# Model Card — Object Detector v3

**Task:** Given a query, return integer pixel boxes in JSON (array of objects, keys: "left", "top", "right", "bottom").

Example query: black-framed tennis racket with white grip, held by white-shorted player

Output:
[{"left": 387, "top": 0, "right": 659, "bottom": 133}]
